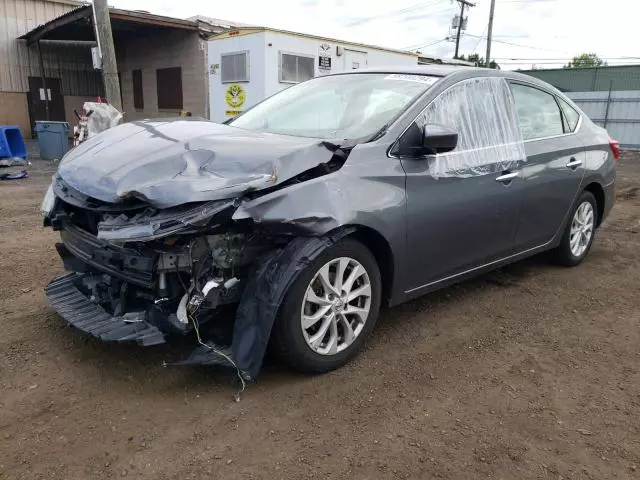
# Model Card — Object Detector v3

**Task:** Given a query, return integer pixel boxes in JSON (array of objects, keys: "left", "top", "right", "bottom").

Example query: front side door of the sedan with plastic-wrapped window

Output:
[{"left": 402, "top": 77, "right": 524, "bottom": 293}]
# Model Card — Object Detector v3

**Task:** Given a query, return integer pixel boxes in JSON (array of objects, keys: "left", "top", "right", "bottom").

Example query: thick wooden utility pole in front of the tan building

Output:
[{"left": 93, "top": 0, "right": 122, "bottom": 112}]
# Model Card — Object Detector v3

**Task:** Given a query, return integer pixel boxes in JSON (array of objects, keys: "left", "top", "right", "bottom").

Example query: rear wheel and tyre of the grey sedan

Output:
[{"left": 553, "top": 190, "right": 598, "bottom": 267}]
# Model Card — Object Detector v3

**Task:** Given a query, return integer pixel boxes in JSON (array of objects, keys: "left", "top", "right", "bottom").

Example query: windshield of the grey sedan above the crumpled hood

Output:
[{"left": 230, "top": 73, "right": 438, "bottom": 139}]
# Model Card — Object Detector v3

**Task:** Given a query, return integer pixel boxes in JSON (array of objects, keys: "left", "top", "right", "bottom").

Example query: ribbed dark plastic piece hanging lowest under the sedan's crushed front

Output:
[{"left": 45, "top": 273, "right": 165, "bottom": 347}]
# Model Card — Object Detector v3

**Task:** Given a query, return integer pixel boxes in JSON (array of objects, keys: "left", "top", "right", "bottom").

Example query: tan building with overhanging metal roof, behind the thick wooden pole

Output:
[{"left": 0, "top": 0, "right": 240, "bottom": 136}]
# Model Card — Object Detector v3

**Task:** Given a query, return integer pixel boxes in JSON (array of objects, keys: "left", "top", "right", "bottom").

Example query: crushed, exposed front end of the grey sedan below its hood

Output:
[{"left": 46, "top": 179, "right": 287, "bottom": 366}]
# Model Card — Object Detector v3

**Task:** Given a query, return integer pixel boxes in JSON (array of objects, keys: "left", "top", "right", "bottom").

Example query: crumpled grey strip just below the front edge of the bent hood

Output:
[{"left": 98, "top": 200, "right": 234, "bottom": 242}]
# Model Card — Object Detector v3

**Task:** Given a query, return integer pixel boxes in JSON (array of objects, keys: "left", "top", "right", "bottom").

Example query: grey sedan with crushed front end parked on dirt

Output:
[{"left": 43, "top": 67, "right": 618, "bottom": 379}]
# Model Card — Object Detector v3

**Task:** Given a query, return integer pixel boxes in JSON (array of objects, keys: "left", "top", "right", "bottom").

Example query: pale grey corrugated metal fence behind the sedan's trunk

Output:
[{"left": 567, "top": 90, "right": 640, "bottom": 148}]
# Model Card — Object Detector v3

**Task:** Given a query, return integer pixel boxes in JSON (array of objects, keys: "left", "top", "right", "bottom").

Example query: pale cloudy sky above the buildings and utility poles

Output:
[{"left": 109, "top": 0, "right": 640, "bottom": 70}]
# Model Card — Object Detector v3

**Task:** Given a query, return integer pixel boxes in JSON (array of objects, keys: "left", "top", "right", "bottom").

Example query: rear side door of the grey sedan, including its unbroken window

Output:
[{"left": 511, "top": 82, "right": 586, "bottom": 252}]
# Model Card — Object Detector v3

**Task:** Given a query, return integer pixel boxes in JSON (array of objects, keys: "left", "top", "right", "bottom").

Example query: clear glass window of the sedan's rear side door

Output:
[{"left": 511, "top": 83, "right": 564, "bottom": 140}]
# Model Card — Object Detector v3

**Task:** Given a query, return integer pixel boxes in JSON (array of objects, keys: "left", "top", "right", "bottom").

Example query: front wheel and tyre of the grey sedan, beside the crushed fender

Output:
[{"left": 272, "top": 239, "right": 381, "bottom": 373}]
